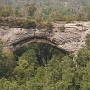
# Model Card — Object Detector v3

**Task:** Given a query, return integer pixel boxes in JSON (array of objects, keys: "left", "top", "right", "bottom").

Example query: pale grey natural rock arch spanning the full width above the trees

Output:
[{"left": 0, "top": 21, "right": 90, "bottom": 52}]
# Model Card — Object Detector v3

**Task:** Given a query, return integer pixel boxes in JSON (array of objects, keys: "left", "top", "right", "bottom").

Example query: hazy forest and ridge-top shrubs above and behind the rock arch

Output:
[{"left": 0, "top": 0, "right": 90, "bottom": 29}]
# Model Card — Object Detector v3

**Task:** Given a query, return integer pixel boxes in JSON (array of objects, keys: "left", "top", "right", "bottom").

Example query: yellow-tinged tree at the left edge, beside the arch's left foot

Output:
[{"left": 0, "top": 41, "right": 15, "bottom": 78}]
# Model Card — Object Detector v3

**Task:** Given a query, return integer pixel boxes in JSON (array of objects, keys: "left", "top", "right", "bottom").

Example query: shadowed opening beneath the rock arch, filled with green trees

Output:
[{"left": 14, "top": 42, "right": 66, "bottom": 66}]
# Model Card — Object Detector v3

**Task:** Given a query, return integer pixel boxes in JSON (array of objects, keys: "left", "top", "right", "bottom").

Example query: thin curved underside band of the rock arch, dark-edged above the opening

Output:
[{"left": 11, "top": 37, "right": 69, "bottom": 54}]
